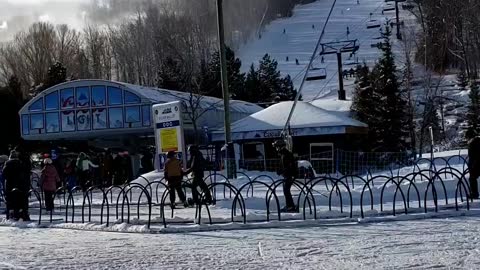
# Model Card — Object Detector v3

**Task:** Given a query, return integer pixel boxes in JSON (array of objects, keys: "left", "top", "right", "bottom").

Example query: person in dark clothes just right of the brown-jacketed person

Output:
[{"left": 184, "top": 145, "right": 212, "bottom": 204}]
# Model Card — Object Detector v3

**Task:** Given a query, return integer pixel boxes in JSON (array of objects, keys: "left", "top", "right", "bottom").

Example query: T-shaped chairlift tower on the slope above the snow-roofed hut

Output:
[{"left": 320, "top": 39, "right": 360, "bottom": 100}]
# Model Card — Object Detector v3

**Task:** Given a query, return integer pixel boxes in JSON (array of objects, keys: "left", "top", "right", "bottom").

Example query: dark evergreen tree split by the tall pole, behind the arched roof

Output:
[{"left": 204, "top": 47, "right": 245, "bottom": 98}]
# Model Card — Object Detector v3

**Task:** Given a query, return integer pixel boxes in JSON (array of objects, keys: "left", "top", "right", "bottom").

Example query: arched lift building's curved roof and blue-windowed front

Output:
[{"left": 19, "top": 80, "right": 262, "bottom": 147}]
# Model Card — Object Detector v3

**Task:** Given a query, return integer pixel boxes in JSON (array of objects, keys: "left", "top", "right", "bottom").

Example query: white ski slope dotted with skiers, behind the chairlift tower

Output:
[{"left": 238, "top": 0, "right": 408, "bottom": 101}]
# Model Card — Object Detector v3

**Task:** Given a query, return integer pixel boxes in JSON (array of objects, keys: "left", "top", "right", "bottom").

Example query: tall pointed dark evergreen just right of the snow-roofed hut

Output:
[{"left": 352, "top": 26, "right": 409, "bottom": 152}]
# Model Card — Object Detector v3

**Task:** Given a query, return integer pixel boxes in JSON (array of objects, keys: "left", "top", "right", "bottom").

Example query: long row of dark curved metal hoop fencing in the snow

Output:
[{"left": 0, "top": 155, "right": 471, "bottom": 231}]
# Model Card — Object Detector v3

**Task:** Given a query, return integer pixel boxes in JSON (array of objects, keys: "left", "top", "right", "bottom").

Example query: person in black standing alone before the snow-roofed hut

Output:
[{"left": 273, "top": 140, "right": 298, "bottom": 213}]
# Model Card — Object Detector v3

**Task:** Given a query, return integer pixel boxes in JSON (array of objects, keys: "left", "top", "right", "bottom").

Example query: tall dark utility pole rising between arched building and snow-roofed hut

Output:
[{"left": 217, "top": 0, "right": 235, "bottom": 178}]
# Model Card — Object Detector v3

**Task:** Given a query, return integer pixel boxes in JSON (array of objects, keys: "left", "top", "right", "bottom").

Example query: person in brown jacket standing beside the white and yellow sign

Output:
[{"left": 164, "top": 151, "right": 188, "bottom": 208}]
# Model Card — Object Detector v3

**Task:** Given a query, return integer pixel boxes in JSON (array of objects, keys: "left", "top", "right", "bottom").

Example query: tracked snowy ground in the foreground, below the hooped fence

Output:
[{"left": 0, "top": 216, "right": 480, "bottom": 269}]
